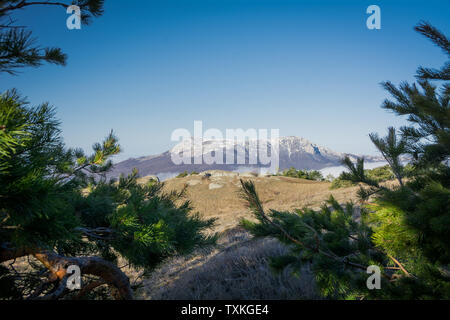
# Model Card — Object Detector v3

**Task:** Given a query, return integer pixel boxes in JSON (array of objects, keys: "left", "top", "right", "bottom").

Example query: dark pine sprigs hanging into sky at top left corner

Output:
[{"left": 0, "top": 0, "right": 104, "bottom": 74}]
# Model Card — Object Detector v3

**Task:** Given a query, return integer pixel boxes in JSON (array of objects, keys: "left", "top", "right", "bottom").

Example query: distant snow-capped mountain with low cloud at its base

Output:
[{"left": 108, "top": 136, "right": 384, "bottom": 180}]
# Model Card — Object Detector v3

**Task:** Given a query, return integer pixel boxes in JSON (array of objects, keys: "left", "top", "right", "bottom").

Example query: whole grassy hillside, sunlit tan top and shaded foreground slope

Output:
[{"left": 127, "top": 171, "right": 364, "bottom": 300}]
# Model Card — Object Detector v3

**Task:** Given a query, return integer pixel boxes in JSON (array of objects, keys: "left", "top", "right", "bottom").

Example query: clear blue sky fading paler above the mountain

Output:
[{"left": 0, "top": 0, "right": 450, "bottom": 159}]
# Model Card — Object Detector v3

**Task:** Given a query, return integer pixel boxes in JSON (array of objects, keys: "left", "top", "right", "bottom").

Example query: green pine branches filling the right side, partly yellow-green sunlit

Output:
[{"left": 242, "top": 24, "right": 450, "bottom": 299}]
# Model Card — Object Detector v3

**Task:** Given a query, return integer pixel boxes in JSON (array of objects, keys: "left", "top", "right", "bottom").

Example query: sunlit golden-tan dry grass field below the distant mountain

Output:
[{"left": 160, "top": 175, "right": 357, "bottom": 232}]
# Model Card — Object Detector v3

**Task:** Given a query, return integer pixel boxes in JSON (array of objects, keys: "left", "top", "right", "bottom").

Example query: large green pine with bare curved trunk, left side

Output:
[{"left": 0, "top": 91, "right": 215, "bottom": 299}]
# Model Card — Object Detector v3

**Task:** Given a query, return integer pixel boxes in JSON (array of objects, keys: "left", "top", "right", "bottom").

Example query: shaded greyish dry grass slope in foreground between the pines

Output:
[{"left": 136, "top": 228, "right": 320, "bottom": 300}]
